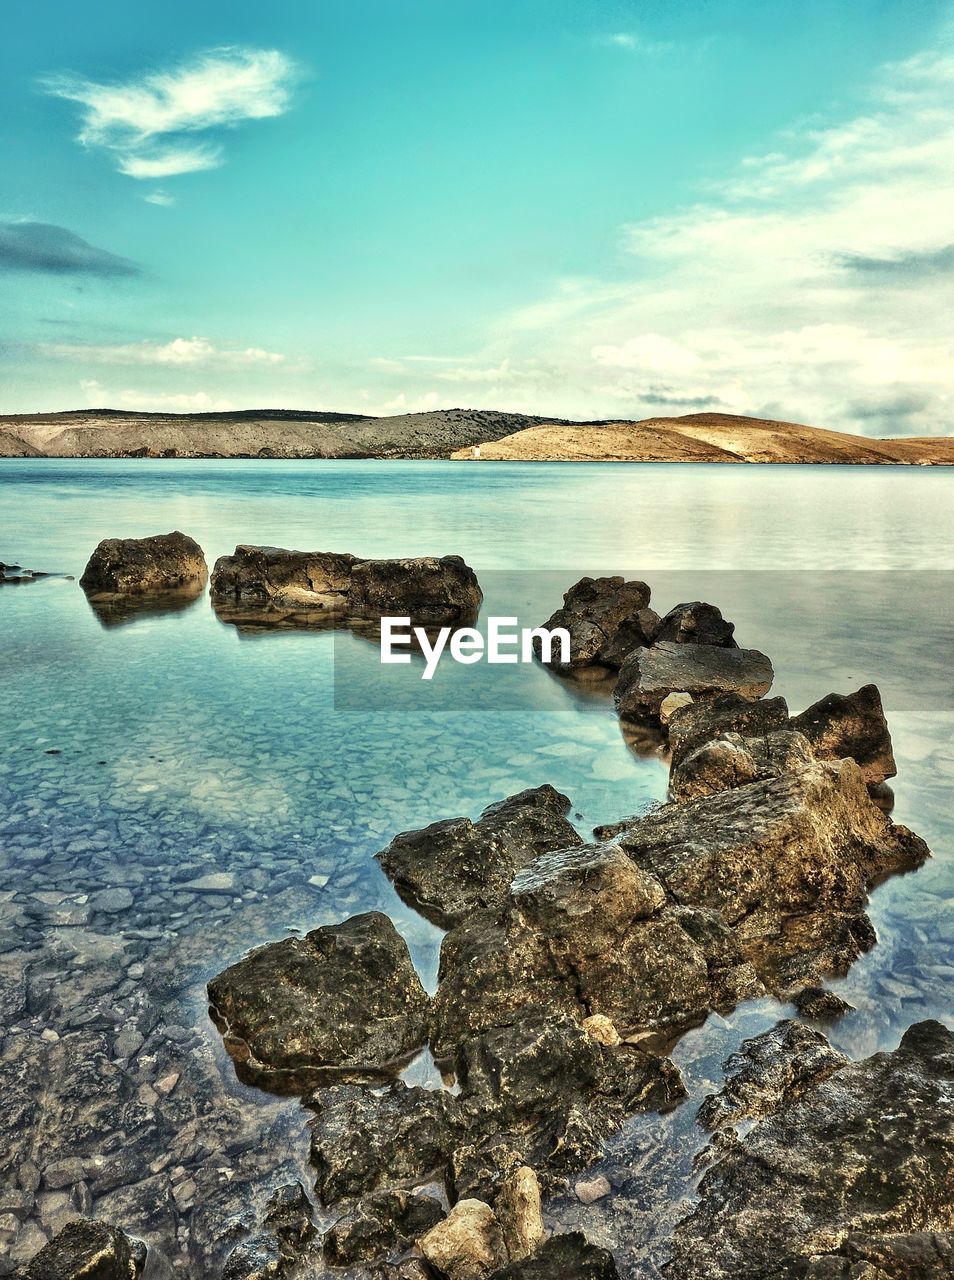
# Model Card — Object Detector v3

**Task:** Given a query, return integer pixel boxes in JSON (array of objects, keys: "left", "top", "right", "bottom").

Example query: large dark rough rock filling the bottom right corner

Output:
[{"left": 665, "top": 1021, "right": 954, "bottom": 1280}]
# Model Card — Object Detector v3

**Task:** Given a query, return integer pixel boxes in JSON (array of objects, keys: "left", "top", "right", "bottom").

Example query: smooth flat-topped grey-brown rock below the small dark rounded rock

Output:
[{"left": 613, "top": 640, "right": 773, "bottom": 719}]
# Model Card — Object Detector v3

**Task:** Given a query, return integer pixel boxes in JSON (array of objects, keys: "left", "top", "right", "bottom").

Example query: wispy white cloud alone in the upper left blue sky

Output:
[{"left": 41, "top": 47, "right": 298, "bottom": 179}]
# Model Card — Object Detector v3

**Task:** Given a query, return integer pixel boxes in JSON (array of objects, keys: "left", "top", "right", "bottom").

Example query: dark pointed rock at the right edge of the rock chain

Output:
[{"left": 791, "top": 685, "right": 898, "bottom": 786}]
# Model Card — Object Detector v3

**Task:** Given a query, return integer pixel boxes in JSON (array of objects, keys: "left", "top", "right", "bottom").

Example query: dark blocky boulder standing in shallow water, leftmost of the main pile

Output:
[{"left": 209, "top": 911, "right": 428, "bottom": 1074}]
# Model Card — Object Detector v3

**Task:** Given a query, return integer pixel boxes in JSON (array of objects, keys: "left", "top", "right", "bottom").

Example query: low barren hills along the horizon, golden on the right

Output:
[{"left": 0, "top": 408, "right": 954, "bottom": 466}]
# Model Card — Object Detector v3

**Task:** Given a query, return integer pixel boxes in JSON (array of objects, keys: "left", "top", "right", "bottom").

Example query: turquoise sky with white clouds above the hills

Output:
[{"left": 0, "top": 0, "right": 954, "bottom": 436}]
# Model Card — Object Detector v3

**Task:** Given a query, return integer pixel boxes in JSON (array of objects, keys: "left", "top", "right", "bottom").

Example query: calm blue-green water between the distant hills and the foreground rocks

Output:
[{"left": 0, "top": 460, "right": 954, "bottom": 1275}]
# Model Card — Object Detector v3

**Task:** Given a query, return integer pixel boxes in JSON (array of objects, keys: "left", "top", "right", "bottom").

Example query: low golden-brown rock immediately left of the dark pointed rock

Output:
[{"left": 670, "top": 730, "right": 814, "bottom": 800}]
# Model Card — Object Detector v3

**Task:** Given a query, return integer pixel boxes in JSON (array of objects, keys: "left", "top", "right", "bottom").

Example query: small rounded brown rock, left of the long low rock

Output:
[{"left": 79, "top": 530, "right": 209, "bottom": 595}]
